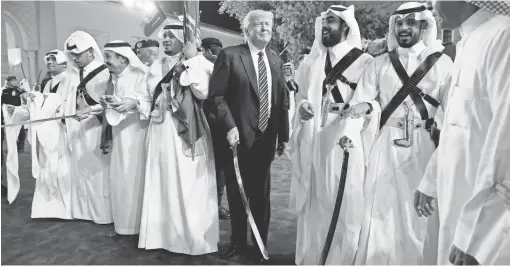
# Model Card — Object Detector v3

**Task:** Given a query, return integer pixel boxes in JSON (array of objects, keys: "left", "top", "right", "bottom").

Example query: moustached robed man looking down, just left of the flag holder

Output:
[{"left": 93, "top": 41, "right": 149, "bottom": 235}]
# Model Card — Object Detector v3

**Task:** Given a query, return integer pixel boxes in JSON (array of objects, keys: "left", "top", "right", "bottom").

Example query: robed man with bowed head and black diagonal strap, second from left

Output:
[{"left": 64, "top": 31, "right": 113, "bottom": 224}]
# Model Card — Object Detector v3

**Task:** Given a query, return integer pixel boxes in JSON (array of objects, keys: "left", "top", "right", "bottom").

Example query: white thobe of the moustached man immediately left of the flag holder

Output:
[{"left": 105, "top": 65, "right": 149, "bottom": 235}]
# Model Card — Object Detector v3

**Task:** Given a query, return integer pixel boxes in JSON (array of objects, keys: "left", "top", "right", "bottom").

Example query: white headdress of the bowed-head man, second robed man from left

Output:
[{"left": 64, "top": 31, "right": 104, "bottom": 71}]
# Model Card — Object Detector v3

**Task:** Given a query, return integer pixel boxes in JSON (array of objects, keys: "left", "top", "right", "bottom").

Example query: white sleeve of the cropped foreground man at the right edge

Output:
[{"left": 454, "top": 28, "right": 510, "bottom": 265}]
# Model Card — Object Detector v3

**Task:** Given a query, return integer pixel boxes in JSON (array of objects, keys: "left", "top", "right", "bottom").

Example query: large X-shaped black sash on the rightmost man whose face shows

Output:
[{"left": 379, "top": 49, "right": 443, "bottom": 128}]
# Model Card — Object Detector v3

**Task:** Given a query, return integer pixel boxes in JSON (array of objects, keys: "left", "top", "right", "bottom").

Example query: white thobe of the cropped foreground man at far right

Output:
[{"left": 419, "top": 9, "right": 510, "bottom": 265}]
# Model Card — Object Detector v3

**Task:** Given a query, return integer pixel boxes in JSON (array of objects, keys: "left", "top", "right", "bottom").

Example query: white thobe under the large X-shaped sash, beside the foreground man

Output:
[{"left": 348, "top": 42, "right": 453, "bottom": 264}]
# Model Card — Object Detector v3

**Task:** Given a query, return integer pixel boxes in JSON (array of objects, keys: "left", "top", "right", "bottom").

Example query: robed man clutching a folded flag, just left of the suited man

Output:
[{"left": 138, "top": 24, "right": 219, "bottom": 255}]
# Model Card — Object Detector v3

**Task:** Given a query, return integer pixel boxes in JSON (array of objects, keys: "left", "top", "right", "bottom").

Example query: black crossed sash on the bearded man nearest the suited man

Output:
[{"left": 322, "top": 48, "right": 363, "bottom": 103}]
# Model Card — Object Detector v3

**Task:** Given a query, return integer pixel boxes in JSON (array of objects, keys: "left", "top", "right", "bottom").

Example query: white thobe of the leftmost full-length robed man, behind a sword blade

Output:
[{"left": 29, "top": 72, "right": 72, "bottom": 219}]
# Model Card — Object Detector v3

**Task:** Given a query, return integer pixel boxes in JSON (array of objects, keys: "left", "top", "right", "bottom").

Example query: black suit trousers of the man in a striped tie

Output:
[{"left": 224, "top": 127, "right": 276, "bottom": 254}]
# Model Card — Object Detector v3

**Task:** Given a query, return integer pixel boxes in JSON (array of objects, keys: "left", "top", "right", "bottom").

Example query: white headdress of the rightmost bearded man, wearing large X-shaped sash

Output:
[{"left": 388, "top": 2, "right": 437, "bottom": 51}]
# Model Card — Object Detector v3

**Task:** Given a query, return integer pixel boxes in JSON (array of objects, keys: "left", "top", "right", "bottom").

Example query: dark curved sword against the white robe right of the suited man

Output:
[{"left": 319, "top": 148, "right": 349, "bottom": 265}]
